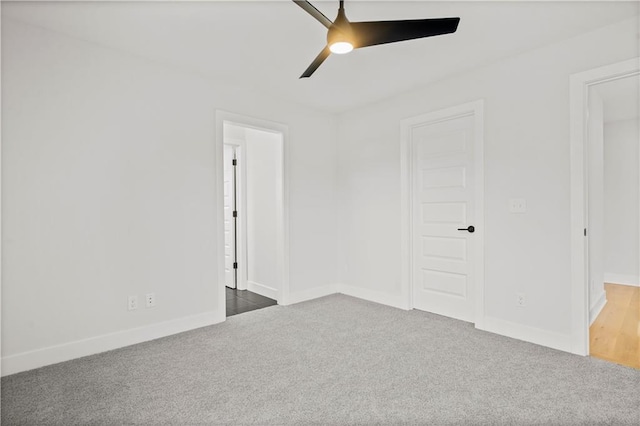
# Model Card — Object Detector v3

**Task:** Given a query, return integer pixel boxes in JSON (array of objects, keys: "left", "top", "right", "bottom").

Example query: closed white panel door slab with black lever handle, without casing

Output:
[{"left": 410, "top": 115, "right": 475, "bottom": 322}]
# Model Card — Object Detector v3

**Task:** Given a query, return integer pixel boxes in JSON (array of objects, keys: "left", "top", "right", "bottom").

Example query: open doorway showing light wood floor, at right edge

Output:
[{"left": 587, "top": 75, "right": 640, "bottom": 368}]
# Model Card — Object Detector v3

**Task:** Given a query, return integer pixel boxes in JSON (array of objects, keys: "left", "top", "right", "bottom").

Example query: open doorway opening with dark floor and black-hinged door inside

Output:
[{"left": 217, "top": 112, "right": 287, "bottom": 317}]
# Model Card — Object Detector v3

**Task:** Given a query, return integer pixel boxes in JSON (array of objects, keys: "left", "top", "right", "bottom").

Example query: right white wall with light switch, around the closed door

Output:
[{"left": 338, "top": 18, "right": 638, "bottom": 350}]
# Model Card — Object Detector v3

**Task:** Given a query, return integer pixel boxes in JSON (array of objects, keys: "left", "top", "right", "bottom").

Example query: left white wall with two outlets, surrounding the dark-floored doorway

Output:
[{"left": 2, "top": 18, "right": 337, "bottom": 374}]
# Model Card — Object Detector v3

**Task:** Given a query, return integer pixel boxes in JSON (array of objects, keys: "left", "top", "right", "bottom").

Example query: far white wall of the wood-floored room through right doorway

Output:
[{"left": 604, "top": 119, "right": 640, "bottom": 285}]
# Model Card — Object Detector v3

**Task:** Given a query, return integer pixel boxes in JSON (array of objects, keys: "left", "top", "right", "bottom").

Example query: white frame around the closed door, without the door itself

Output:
[{"left": 400, "top": 99, "right": 485, "bottom": 328}]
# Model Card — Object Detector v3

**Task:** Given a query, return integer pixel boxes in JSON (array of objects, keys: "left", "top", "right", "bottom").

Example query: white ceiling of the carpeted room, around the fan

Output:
[{"left": 2, "top": 1, "right": 639, "bottom": 112}]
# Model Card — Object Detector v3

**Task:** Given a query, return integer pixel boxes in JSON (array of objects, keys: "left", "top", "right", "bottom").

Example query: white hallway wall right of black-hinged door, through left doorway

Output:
[{"left": 246, "top": 129, "right": 282, "bottom": 297}]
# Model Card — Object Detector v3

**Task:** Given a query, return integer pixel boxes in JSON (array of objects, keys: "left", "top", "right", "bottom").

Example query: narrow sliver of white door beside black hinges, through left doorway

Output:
[{"left": 223, "top": 145, "right": 237, "bottom": 288}]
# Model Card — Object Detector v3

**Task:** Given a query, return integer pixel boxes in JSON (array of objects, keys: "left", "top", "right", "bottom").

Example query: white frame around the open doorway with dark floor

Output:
[{"left": 215, "top": 110, "right": 290, "bottom": 315}]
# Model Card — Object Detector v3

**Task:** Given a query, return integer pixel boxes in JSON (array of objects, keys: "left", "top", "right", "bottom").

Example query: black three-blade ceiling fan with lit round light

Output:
[{"left": 293, "top": 0, "right": 460, "bottom": 78}]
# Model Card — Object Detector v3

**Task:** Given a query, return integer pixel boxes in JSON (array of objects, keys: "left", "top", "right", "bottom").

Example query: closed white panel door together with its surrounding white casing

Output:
[{"left": 401, "top": 101, "right": 484, "bottom": 328}]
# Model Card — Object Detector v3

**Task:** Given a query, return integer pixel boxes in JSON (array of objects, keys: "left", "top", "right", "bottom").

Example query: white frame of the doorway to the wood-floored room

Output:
[{"left": 569, "top": 57, "right": 640, "bottom": 356}]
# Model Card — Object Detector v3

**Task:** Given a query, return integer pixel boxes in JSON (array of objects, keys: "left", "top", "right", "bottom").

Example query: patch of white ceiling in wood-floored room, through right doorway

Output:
[{"left": 595, "top": 75, "right": 640, "bottom": 123}]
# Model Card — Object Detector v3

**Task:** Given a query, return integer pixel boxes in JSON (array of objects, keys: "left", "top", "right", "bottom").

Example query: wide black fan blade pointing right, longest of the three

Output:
[{"left": 351, "top": 18, "right": 460, "bottom": 47}]
